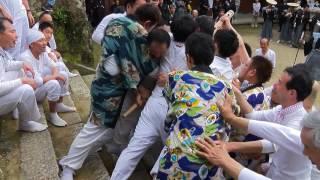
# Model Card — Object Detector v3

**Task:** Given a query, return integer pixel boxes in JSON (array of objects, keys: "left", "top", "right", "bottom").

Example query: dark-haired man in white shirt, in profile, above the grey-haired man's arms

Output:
[{"left": 228, "top": 64, "right": 313, "bottom": 180}]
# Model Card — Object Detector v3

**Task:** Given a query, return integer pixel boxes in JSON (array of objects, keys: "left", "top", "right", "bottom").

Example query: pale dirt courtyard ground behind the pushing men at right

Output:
[{"left": 236, "top": 25, "right": 320, "bottom": 108}]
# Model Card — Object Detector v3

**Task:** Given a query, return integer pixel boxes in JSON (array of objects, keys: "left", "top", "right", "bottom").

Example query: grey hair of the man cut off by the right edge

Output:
[{"left": 302, "top": 111, "right": 320, "bottom": 148}]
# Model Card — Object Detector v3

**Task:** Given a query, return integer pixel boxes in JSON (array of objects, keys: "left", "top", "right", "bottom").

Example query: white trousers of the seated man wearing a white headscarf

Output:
[{"left": 35, "top": 80, "right": 61, "bottom": 102}]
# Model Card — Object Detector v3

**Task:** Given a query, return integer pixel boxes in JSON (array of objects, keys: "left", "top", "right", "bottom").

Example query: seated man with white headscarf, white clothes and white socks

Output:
[{"left": 19, "top": 30, "right": 75, "bottom": 126}]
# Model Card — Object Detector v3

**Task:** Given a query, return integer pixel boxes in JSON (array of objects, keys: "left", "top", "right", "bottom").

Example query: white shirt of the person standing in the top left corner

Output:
[{"left": 0, "top": 0, "right": 27, "bottom": 19}]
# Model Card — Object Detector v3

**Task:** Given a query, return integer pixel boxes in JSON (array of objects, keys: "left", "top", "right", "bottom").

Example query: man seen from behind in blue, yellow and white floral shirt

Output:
[{"left": 157, "top": 33, "right": 239, "bottom": 179}]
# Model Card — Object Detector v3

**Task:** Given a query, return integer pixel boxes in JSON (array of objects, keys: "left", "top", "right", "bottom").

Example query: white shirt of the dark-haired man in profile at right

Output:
[{"left": 246, "top": 102, "right": 311, "bottom": 180}]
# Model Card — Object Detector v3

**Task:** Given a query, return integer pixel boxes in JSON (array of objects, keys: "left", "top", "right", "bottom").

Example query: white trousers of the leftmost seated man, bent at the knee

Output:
[{"left": 0, "top": 84, "right": 41, "bottom": 124}]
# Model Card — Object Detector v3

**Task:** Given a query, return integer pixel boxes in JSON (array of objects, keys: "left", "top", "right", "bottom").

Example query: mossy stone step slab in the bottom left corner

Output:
[{"left": 0, "top": 105, "right": 59, "bottom": 180}]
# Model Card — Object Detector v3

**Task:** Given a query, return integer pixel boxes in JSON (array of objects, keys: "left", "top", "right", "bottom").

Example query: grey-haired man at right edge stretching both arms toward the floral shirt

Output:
[{"left": 197, "top": 102, "right": 320, "bottom": 180}]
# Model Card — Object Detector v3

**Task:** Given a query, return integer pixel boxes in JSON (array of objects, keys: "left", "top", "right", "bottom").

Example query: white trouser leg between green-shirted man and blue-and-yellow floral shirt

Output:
[{"left": 111, "top": 96, "right": 168, "bottom": 180}]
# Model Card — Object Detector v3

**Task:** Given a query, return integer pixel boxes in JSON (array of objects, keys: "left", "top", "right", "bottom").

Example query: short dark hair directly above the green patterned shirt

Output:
[{"left": 135, "top": 4, "right": 161, "bottom": 24}]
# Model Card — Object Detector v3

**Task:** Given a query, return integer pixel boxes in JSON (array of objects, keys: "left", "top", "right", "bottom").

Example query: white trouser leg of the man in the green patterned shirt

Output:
[{"left": 59, "top": 113, "right": 113, "bottom": 170}]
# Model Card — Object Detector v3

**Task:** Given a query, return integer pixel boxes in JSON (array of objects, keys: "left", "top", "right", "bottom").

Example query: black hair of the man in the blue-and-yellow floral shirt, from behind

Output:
[{"left": 185, "top": 32, "right": 213, "bottom": 66}]
